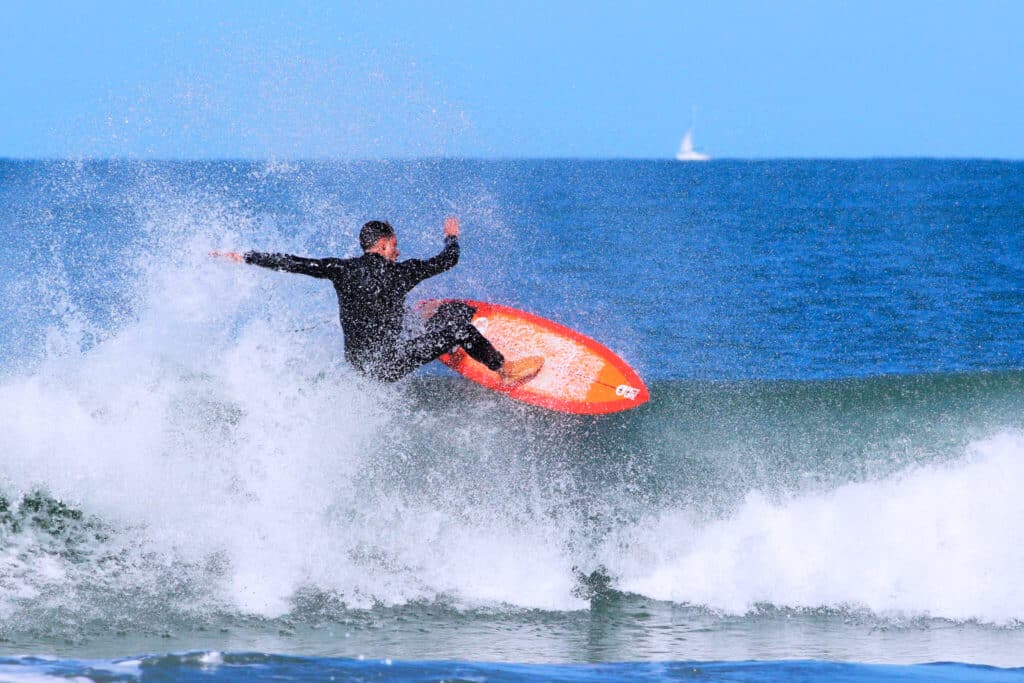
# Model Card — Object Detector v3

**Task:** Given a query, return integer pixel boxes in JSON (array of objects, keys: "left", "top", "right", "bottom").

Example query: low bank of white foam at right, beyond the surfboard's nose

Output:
[{"left": 608, "top": 433, "right": 1024, "bottom": 624}]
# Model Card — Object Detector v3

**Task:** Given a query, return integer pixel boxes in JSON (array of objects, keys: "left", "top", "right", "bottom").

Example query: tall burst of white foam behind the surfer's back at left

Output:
[{"left": 0, "top": 181, "right": 581, "bottom": 616}]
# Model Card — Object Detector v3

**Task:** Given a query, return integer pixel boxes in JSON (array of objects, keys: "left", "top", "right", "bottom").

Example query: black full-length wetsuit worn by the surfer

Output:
[{"left": 245, "top": 237, "right": 504, "bottom": 382}]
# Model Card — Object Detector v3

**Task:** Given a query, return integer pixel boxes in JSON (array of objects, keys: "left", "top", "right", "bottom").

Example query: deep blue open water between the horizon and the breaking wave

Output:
[{"left": 0, "top": 160, "right": 1024, "bottom": 380}]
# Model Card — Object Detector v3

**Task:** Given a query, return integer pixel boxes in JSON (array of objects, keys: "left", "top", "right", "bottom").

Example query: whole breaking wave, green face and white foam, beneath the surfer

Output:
[{"left": 0, "top": 160, "right": 1024, "bottom": 659}]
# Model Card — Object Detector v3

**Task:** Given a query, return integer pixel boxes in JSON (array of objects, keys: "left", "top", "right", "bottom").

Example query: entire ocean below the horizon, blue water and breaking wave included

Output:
[{"left": 0, "top": 159, "right": 1024, "bottom": 681}]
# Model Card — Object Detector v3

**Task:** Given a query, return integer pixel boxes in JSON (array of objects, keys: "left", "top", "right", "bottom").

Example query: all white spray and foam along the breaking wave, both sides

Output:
[{"left": 0, "top": 167, "right": 1024, "bottom": 643}]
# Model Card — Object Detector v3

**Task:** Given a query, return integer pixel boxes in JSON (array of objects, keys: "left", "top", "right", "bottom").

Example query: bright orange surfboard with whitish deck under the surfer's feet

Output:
[{"left": 420, "top": 300, "right": 650, "bottom": 415}]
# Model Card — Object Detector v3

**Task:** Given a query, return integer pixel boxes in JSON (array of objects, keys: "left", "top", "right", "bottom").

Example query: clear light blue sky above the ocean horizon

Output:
[{"left": 0, "top": 0, "right": 1024, "bottom": 159}]
